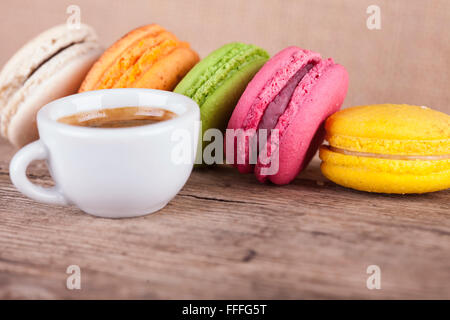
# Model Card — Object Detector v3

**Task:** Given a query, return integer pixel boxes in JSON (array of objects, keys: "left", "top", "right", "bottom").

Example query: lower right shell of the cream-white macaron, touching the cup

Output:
[{"left": 1, "top": 42, "right": 102, "bottom": 147}]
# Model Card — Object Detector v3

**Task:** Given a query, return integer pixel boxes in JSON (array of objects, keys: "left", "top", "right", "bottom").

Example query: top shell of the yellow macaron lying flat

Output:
[{"left": 326, "top": 104, "right": 450, "bottom": 155}]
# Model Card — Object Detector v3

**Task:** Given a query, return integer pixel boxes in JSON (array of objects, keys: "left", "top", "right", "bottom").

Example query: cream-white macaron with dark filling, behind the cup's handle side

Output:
[{"left": 0, "top": 24, "right": 102, "bottom": 147}]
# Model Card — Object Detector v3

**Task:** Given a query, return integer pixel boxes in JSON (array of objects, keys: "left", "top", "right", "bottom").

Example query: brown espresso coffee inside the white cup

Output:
[{"left": 58, "top": 107, "right": 177, "bottom": 128}]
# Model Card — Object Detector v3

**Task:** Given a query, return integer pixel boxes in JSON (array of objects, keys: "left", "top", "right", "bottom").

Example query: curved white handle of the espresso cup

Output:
[{"left": 9, "top": 140, "right": 69, "bottom": 205}]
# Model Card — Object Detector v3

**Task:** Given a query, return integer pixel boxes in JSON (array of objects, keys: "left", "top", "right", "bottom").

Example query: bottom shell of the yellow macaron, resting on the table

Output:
[{"left": 319, "top": 147, "right": 450, "bottom": 194}]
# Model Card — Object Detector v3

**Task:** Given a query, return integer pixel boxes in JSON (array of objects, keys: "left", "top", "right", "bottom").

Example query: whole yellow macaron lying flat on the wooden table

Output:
[{"left": 319, "top": 104, "right": 450, "bottom": 193}]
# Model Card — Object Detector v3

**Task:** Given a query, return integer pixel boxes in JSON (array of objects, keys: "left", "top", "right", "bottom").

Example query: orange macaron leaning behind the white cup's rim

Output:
[{"left": 79, "top": 24, "right": 199, "bottom": 92}]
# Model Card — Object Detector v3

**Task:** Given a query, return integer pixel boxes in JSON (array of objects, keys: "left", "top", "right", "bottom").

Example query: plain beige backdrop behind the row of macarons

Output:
[{"left": 0, "top": 0, "right": 450, "bottom": 113}]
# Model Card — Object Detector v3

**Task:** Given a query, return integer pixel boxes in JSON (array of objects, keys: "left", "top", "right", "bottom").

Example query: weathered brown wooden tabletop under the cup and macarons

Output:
[{"left": 0, "top": 141, "right": 450, "bottom": 299}]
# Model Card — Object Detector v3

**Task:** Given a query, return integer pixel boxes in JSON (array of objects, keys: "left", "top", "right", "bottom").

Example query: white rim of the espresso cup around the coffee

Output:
[{"left": 37, "top": 88, "right": 200, "bottom": 136}]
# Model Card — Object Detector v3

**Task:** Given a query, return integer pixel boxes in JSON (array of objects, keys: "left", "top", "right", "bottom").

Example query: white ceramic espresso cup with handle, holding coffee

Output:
[{"left": 10, "top": 89, "right": 200, "bottom": 218}]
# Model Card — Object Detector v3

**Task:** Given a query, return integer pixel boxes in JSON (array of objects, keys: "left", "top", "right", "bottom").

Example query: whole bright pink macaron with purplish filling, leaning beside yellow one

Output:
[{"left": 225, "top": 47, "right": 348, "bottom": 184}]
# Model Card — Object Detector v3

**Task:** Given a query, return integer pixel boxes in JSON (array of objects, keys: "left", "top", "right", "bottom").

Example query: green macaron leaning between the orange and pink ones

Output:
[{"left": 174, "top": 42, "right": 269, "bottom": 162}]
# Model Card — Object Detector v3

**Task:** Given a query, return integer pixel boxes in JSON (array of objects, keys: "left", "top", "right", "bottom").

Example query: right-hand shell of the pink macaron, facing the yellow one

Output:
[{"left": 255, "top": 59, "right": 348, "bottom": 184}]
